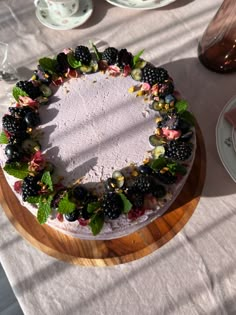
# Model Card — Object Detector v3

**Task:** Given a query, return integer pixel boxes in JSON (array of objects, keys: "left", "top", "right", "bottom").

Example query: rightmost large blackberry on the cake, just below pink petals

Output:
[{"left": 165, "top": 141, "right": 192, "bottom": 161}]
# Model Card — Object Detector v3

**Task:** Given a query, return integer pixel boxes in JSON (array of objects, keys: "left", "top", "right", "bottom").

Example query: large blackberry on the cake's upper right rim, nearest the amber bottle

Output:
[{"left": 142, "top": 66, "right": 169, "bottom": 86}]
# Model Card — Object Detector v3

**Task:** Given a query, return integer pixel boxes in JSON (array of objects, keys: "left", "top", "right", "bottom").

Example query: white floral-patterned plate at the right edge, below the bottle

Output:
[{"left": 216, "top": 96, "right": 236, "bottom": 182}]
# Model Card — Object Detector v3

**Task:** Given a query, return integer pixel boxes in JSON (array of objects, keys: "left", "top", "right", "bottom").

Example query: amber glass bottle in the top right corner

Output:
[{"left": 198, "top": 0, "right": 236, "bottom": 73}]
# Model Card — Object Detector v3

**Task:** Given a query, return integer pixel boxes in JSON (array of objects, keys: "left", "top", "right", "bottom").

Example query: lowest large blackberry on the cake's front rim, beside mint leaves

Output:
[{"left": 102, "top": 193, "right": 123, "bottom": 220}]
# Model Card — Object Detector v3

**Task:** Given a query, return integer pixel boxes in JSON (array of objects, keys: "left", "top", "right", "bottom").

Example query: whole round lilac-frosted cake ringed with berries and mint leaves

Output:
[{"left": 0, "top": 45, "right": 196, "bottom": 239}]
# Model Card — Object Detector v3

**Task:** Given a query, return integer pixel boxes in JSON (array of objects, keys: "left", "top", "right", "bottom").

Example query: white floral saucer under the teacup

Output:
[{"left": 36, "top": 0, "right": 93, "bottom": 31}]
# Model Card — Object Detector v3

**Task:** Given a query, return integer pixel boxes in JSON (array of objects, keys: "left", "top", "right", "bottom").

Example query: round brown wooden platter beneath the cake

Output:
[{"left": 0, "top": 127, "right": 206, "bottom": 266}]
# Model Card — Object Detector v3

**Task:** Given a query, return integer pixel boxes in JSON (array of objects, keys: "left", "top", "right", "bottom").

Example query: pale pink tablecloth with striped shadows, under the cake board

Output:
[{"left": 0, "top": 0, "right": 236, "bottom": 315}]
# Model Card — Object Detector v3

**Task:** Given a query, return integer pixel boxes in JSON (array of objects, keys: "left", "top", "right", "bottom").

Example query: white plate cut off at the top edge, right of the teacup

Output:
[{"left": 106, "top": 0, "right": 176, "bottom": 10}]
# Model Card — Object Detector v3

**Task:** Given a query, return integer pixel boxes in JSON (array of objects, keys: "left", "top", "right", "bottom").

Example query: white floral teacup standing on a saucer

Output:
[{"left": 34, "top": 0, "right": 79, "bottom": 18}]
